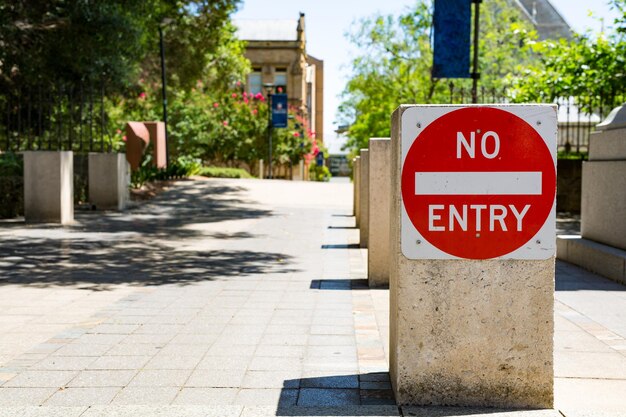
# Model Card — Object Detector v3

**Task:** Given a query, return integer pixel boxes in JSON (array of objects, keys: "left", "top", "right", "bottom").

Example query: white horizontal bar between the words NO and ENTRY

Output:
[{"left": 415, "top": 172, "right": 541, "bottom": 195}]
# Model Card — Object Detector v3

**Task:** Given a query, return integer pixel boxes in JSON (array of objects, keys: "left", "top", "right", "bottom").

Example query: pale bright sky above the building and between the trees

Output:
[{"left": 233, "top": 0, "right": 616, "bottom": 153}]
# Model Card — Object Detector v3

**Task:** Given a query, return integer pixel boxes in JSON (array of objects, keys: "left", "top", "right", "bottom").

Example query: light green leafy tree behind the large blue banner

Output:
[{"left": 339, "top": 0, "right": 534, "bottom": 149}]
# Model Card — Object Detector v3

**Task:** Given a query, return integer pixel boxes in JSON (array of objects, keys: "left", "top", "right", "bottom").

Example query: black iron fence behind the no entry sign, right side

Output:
[{"left": 448, "top": 83, "right": 626, "bottom": 153}]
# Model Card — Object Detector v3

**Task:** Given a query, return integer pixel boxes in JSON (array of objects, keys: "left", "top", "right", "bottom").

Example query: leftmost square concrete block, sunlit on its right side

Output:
[{"left": 24, "top": 151, "right": 74, "bottom": 224}]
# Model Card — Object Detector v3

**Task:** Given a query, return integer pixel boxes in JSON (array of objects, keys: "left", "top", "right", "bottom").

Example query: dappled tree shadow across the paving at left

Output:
[{"left": 0, "top": 182, "right": 294, "bottom": 290}]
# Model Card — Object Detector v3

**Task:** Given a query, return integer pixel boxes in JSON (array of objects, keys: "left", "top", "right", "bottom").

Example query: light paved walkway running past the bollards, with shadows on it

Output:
[{"left": 0, "top": 180, "right": 626, "bottom": 417}]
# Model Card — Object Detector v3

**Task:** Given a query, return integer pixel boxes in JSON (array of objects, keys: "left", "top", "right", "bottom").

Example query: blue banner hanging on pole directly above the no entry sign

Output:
[{"left": 433, "top": 0, "right": 472, "bottom": 78}]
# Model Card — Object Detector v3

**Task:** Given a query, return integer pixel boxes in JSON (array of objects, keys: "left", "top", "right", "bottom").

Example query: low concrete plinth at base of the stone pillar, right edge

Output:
[{"left": 556, "top": 235, "right": 626, "bottom": 284}]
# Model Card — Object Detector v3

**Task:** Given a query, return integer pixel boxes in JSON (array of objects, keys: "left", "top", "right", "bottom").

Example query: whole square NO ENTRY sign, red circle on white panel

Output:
[{"left": 401, "top": 105, "right": 557, "bottom": 259}]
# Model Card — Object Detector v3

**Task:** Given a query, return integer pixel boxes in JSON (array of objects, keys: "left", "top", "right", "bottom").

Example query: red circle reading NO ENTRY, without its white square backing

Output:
[{"left": 402, "top": 107, "right": 556, "bottom": 259}]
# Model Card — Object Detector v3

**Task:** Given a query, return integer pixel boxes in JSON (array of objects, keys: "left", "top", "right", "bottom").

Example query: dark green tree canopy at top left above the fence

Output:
[{"left": 0, "top": 0, "right": 239, "bottom": 91}]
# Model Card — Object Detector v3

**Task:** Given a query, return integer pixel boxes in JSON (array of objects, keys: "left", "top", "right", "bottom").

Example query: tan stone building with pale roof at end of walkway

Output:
[{"left": 234, "top": 13, "right": 324, "bottom": 142}]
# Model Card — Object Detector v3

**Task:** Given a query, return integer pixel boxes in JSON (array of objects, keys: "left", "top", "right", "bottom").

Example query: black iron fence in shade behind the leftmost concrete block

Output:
[{"left": 0, "top": 82, "right": 112, "bottom": 153}]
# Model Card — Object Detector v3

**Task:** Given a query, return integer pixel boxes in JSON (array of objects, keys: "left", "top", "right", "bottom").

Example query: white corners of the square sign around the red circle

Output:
[{"left": 400, "top": 104, "right": 557, "bottom": 259}]
